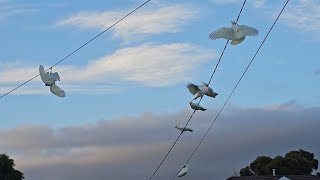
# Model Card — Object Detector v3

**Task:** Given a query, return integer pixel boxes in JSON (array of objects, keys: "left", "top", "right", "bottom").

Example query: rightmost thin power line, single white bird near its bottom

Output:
[{"left": 171, "top": 0, "right": 290, "bottom": 180}]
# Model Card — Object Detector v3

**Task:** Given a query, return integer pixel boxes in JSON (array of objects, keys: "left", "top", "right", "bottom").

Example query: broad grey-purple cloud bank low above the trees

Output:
[{"left": 0, "top": 103, "right": 320, "bottom": 180}]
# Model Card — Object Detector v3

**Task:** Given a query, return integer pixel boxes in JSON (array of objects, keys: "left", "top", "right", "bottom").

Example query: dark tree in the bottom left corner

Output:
[{"left": 0, "top": 154, "right": 24, "bottom": 180}]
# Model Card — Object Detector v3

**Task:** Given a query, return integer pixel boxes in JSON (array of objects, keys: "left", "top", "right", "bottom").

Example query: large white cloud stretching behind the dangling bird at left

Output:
[{"left": 0, "top": 43, "right": 217, "bottom": 93}]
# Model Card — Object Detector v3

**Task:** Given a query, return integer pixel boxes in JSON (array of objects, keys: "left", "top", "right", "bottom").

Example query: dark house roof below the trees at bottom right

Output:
[{"left": 226, "top": 175, "right": 320, "bottom": 180}]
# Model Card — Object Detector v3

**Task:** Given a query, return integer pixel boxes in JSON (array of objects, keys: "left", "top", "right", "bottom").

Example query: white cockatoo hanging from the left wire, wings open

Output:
[{"left": 39, "top": 65, "right": 66, "bottom": 97}]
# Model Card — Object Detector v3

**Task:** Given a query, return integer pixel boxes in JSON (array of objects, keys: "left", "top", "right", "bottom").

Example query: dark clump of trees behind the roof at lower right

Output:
[{"left": 240, "top": 149, "right": 319, "bottom": 176}]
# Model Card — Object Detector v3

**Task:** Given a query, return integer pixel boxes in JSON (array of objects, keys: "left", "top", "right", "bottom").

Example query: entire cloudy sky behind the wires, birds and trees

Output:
[{"left": 0, "top": 0, "right": 320, "bottom": 180}]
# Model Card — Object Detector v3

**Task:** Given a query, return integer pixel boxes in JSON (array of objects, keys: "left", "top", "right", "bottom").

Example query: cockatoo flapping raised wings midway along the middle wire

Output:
[{"left": 187, "top": 82, "right": 218, "bottom": 102}]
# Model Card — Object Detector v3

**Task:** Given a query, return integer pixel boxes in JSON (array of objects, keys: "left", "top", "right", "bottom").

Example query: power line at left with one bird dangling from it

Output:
[{"left": 0, "top": 0, "right": 151, "bottom": 99}]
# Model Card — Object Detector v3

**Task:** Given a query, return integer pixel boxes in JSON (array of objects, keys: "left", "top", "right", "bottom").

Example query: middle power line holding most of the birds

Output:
[{"left": 149, "top": 0, "right": 246, "bottom": 180}]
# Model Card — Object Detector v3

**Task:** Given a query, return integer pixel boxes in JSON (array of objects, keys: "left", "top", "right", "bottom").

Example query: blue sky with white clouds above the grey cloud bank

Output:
[{"left": 0, "top": 0, "right": 320, "bottom": 179}]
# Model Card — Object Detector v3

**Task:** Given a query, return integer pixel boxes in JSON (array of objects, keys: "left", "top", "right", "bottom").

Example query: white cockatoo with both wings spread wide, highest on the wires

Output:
[{"left": 209, "top": 21, "right": 259, "bottom": 45}]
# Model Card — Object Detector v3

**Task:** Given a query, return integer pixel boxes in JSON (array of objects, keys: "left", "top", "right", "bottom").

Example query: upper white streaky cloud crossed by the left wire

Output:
[{"left": 55, "top": 5, "right": 198, "bottom": 42}]
